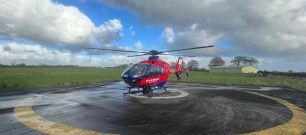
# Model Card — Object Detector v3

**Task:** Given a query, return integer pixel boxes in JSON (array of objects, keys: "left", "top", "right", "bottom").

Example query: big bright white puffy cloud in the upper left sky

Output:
[{"left": 0, "top": 0, "right": 123, "bottom": 48}]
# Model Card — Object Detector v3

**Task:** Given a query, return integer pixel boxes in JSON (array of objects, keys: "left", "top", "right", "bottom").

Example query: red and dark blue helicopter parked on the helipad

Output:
[{"left": 88, "top": 45, "right": 213, "bottom": 96}]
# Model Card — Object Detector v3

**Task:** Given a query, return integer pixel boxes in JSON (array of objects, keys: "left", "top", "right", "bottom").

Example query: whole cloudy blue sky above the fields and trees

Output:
[{"left": 0, "top": 0, "right": 306, "bottom": 72}]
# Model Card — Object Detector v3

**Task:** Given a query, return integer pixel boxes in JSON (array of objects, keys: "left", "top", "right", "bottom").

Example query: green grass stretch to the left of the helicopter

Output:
[{"left": 0, "top": 67, "right": 122, "bottom": 89}]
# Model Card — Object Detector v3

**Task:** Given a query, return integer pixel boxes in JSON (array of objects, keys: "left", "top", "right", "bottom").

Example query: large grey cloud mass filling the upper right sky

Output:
[{"left": 102, "top": 0, "right": 306, "bottom": 58}]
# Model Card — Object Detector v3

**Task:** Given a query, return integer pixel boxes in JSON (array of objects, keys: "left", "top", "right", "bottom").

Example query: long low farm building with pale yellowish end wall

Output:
[{"left": 210, "top": 65, "right": 257, "bottom": 73}]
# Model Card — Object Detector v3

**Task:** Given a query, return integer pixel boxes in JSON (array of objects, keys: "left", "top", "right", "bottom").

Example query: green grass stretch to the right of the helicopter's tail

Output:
[{"left": 169, "top": 71, "right": 306, "bottom": 93}]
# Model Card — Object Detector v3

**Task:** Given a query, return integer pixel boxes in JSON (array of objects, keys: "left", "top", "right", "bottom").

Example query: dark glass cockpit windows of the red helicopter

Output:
[{"left": 122, "top": 63, "right": 164, "bottom": 78}]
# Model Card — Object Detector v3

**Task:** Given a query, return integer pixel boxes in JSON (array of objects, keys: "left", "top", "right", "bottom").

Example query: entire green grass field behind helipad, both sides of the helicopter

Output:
[{"left": 0, "top": 67, "right": 306, "bottom": 92}]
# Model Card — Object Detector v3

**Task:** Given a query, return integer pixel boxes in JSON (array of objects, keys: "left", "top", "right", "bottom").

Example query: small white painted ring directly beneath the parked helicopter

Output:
[{"left": 127, "top": 89, "right": 189, "bottom": 99}]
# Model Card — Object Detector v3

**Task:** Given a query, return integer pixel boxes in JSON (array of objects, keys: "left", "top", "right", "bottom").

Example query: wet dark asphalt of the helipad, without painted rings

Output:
[{"left": 0, "top": 82, "right": 306, "bottom": 135}]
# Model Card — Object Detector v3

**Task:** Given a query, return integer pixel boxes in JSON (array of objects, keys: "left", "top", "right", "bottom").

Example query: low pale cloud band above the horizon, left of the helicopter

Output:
[{"left": 0, "top": 42, "right": 139, "bottom": 67}]
